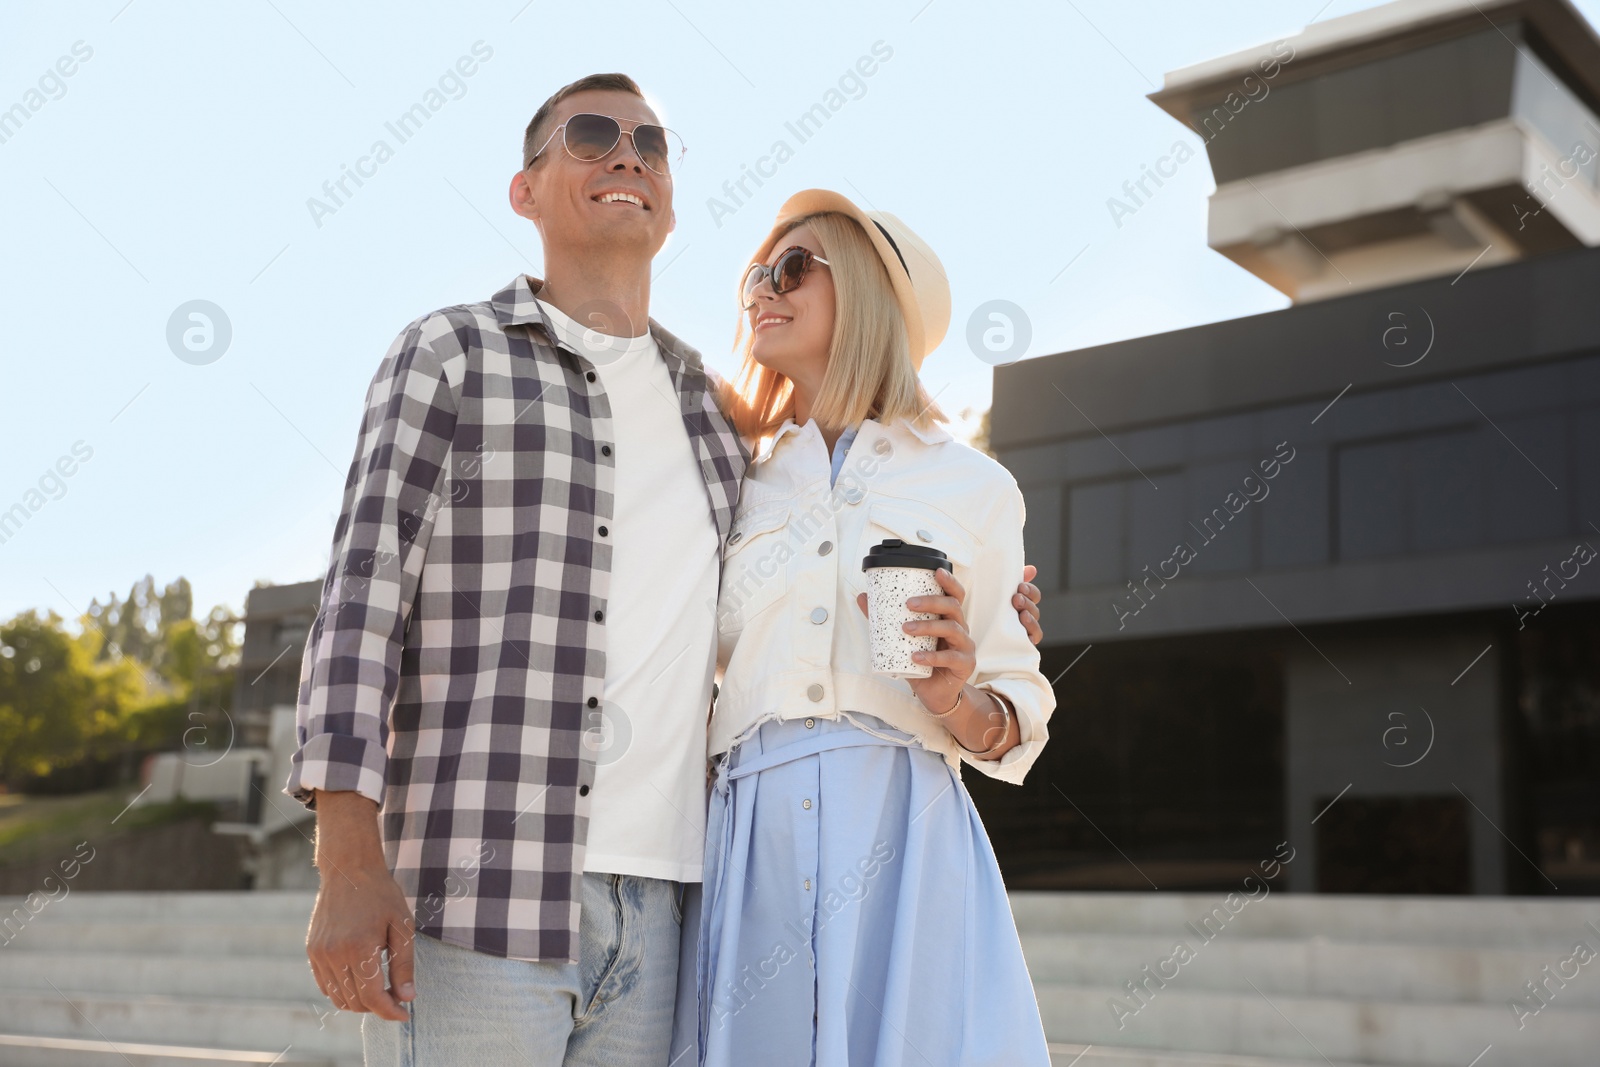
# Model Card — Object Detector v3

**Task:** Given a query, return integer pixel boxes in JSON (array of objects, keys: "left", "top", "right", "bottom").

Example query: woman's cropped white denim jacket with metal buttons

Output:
[{"left": 707, "top": 419, "right": 1056, "bottom": 784}]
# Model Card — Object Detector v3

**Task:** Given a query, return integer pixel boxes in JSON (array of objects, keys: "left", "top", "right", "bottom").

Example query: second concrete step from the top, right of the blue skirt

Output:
[{"left": 1022, "top": 931, "right": 1600, "bottom": 1008}]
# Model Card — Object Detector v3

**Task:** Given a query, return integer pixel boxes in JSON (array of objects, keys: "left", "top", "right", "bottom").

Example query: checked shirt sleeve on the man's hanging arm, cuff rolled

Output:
[{"left": 283, "top": 317, "right": 456, "bottom": 806}]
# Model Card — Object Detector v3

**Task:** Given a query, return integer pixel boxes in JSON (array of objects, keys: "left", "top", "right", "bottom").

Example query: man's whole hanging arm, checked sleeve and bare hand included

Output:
[{"left": 285, "top": 315, "right": 459, "bottom": 1021}]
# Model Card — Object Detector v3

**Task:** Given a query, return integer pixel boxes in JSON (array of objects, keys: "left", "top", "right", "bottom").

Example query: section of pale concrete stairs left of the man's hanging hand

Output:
[{"left": 0, "top": 893, "right": 362, "bottom": 1067}]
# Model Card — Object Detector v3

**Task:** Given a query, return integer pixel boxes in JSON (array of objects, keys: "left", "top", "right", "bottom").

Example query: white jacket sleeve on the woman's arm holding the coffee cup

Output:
[{"left": 960, "top": 483, "right": 1056, "bottom": 785}]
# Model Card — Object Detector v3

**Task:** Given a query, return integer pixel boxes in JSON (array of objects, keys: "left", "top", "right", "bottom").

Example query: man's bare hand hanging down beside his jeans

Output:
[{"left": 306, "top": 789, "right": 416, "bottom": 1022}]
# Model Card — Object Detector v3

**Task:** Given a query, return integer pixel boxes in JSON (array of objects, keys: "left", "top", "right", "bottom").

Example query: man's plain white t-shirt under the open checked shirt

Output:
[{"left": 539, "top": 301, "right": 720, "bottom": 881}]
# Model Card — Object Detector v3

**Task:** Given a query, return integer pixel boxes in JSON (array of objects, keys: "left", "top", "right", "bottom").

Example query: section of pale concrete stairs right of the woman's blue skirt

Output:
[{"left": 1011, "top": 893, "right": 1600, "bottom": 1067}]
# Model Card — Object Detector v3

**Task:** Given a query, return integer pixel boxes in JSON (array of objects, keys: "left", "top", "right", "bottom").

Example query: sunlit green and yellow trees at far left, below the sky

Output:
[{"left": 0, "top": 576, "right": 238, "bottom": 787}]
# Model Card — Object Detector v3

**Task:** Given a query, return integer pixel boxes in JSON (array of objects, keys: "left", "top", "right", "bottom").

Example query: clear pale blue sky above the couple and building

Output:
[{"left": 0, "top": 0, "right": 1600, "bottom": 619}]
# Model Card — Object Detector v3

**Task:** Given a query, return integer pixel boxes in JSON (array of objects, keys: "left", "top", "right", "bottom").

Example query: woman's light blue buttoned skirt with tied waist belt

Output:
[{"left": 672, "top": 712, "right": 1050, "bottom": 1067}]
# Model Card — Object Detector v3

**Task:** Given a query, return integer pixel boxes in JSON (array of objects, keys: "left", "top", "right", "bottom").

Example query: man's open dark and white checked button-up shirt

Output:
[{"left": 286, "top": 275, "right": 749, "bottom": 961}]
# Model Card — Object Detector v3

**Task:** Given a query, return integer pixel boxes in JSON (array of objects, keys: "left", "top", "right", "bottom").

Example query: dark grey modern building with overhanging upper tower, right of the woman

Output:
[{"left": 971, "top": 0, "right": 1600, "bottom": 894}]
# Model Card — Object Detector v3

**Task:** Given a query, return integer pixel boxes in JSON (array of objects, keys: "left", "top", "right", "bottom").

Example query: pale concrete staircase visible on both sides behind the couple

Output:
[{"left": 0, "top": 893, "right": 1600, "bottom": 1067}]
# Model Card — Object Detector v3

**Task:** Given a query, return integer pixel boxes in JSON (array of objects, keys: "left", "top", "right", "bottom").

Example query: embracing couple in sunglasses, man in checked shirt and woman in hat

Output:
[{"left": 286, "top": 74, "right": 1054, "bottom": 1067}]
